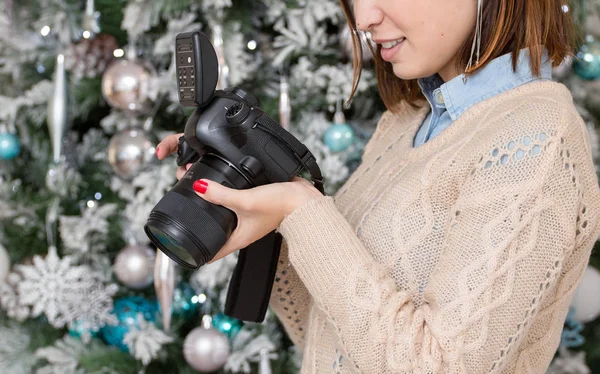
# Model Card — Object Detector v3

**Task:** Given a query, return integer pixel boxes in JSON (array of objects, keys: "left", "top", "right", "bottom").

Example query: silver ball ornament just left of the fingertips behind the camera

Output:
[{"left": 108, "top": 129, "right": 155, "bottom": 179}]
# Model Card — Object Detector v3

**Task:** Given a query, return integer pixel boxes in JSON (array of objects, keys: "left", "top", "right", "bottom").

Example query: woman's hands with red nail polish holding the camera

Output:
[{"left": 156, "top": 134, "right": 323, "bottom": 263}]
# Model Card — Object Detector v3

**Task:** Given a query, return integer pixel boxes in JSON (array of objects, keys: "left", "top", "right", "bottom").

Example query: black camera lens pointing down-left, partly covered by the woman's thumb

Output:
[{"left": 144, "top": 154, "right": 251, "bottom": 269}]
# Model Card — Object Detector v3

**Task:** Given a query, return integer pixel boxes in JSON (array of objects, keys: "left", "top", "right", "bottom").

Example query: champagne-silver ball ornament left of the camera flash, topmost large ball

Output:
[{"left": 102, "top": 59, "right": 155, "bottom": 113}]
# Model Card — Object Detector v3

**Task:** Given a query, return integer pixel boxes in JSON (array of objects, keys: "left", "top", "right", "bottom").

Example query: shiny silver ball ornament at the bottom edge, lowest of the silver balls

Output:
[{"left": 183, "top": 327, "right": 230, "bottom": 373}]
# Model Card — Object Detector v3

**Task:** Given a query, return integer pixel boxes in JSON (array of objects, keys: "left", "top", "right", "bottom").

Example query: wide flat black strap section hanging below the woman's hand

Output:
[{"left": 224, "top": 231, "right": 282, "bottom": 322}]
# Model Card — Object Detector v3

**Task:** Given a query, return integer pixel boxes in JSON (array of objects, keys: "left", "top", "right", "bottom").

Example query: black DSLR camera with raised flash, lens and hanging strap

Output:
[{"left": 144, "top": 31, "right": 324, "bottom": 322}]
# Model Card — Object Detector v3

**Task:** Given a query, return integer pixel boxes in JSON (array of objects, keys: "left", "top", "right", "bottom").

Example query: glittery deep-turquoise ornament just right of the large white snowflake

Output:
[{"left": 100, "top": 296, "right": 158, "bottom": 352}]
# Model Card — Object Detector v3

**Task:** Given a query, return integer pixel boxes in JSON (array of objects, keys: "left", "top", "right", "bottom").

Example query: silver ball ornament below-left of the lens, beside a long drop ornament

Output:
[{"left": 114, "top": 245, "right": 156, "bottom": 290}]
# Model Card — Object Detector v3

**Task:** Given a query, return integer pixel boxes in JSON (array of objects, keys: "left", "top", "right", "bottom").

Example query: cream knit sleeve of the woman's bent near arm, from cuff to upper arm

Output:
[{"left": 279, "top": 125, "right": 598, "bottom": 374}]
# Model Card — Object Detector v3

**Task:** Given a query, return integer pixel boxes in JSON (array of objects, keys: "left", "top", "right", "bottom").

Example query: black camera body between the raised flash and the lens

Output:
[{"left": 178, "top": 88, "right": 310, "bottom": 187}]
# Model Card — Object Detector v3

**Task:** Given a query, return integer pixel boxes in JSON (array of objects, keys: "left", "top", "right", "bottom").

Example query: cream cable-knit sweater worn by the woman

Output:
[{"left": 271, "top": 81, "right": 600, "bottom": 374}]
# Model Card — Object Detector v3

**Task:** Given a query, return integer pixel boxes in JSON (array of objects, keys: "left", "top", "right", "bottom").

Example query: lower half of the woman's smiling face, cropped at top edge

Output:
[{"left": 354, "top": 0, "right": 477, "bottom": 81}]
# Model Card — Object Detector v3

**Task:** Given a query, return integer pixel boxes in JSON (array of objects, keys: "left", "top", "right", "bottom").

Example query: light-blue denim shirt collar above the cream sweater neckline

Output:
[{"left": 418, "top": 48, "right": 552, "bottom": 121}]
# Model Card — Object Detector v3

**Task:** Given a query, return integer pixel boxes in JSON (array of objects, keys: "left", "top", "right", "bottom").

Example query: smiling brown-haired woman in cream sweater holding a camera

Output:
[{"left": 157, "top": 0, "right": 600, "bottom": 374}]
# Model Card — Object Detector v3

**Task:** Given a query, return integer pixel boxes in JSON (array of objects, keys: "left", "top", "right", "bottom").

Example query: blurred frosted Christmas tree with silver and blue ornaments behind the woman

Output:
[{"left": 0, "top": 0, "right": 600, "bottom": 374}]
